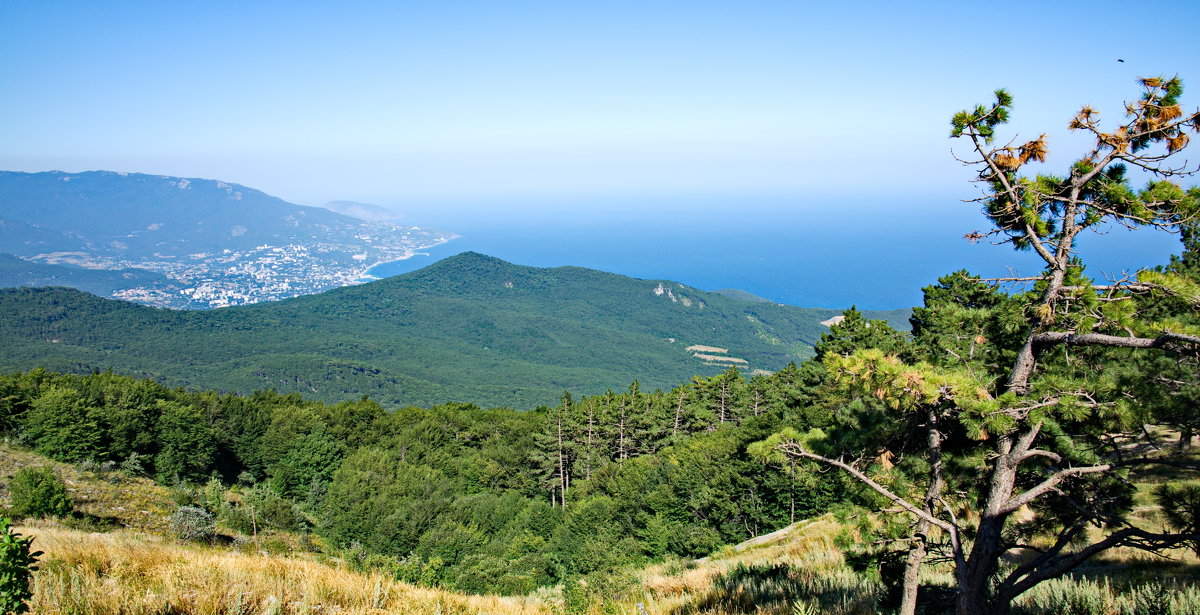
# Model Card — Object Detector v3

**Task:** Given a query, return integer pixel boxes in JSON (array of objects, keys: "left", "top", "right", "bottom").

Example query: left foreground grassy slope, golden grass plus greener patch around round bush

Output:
[{"left": 0, "top": 444, "right": 550, "bottom": 615}]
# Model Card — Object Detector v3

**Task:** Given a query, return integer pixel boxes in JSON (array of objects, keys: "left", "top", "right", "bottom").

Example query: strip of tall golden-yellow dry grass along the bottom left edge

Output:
[{"left": 18, "top": 524, "right": 550, "bottom": 615}]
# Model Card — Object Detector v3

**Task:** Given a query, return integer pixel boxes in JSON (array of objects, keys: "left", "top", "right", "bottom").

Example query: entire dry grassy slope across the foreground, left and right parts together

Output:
[{"left": 0, "top": 444, "right": 1200, "bottom": 615}]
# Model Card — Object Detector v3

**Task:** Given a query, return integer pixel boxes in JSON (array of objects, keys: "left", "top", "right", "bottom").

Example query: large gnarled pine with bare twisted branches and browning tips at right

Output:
[{"left": 760, "top": 78, "right": 1200, "bottom": 615}]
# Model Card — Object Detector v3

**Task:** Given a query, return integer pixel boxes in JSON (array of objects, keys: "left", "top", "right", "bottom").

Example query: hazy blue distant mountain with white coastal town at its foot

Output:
[{"left": 0, "top": 171, "right": 455, "bottom": 309}]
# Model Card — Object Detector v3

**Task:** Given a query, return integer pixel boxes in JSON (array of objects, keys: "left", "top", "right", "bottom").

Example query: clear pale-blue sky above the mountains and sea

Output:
[{"left": 0, "top": 0, "right": 1200, "bottom": 212}]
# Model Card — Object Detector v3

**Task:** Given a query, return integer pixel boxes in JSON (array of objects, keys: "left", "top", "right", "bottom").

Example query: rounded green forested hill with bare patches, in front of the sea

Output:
[{"left": 0, "top": 252, "right": 907, "bottom": 408}]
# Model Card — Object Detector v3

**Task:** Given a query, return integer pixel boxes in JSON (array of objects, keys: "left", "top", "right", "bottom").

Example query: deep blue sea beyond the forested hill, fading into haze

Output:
[{"left": 368, "top": 197, "right": 1180, "bottom": 310}]
